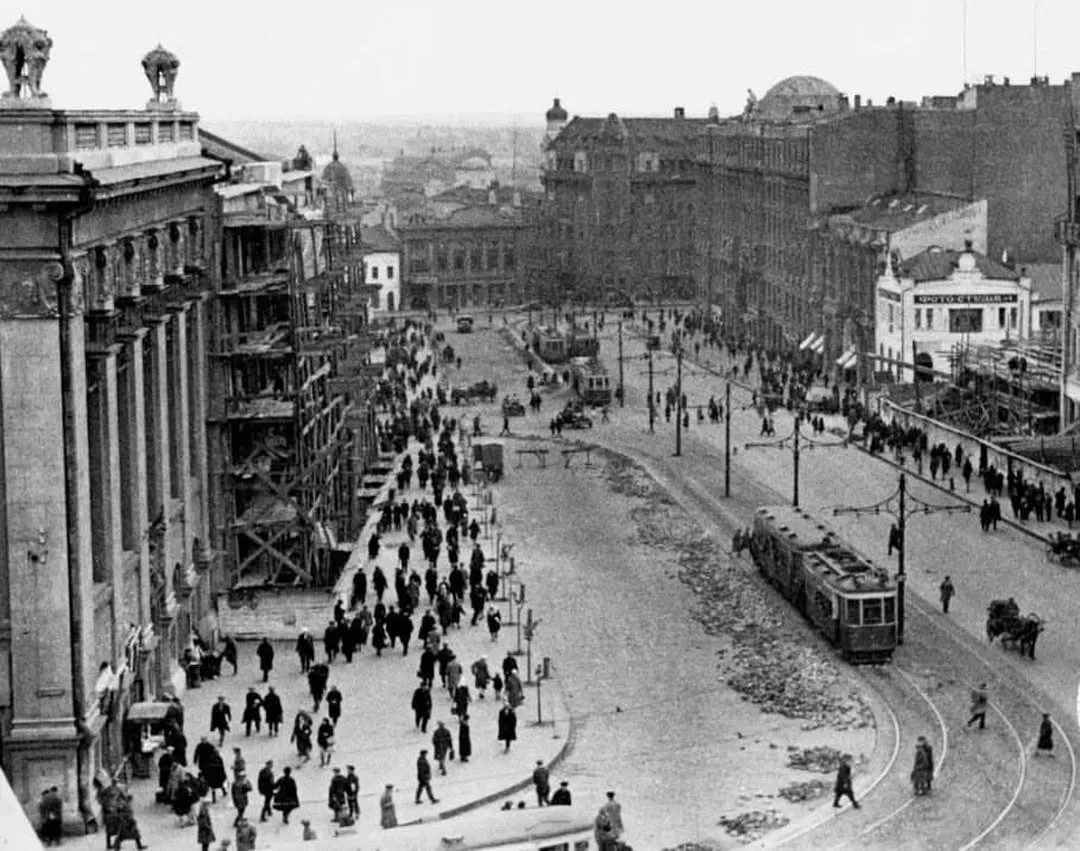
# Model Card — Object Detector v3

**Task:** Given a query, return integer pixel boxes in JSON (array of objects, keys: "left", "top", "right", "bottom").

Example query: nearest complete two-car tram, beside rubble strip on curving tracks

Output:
[{"left": 750, "top": 505, "right": 896, "bottom": 664}]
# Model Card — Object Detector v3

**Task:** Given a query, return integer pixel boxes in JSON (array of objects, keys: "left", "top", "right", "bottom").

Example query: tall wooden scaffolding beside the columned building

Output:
[{"left": 211, "top": 216, "right": 374, "bottom": 589}]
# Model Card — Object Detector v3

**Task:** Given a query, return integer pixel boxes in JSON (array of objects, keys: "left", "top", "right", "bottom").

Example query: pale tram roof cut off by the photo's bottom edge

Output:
[{"left": 264, "top": 807, "right": 597, "bottom": 851}]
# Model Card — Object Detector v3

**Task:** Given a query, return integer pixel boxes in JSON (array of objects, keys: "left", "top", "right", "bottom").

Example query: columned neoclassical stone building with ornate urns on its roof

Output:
[{"left": 0, "top": 19, "right": 224, "bottom": 824}]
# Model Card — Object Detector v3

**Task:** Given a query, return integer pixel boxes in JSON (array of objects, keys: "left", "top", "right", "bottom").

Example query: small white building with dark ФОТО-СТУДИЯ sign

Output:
[{"left": 875, "top": 243, "right": 1031, "bottom": 381}]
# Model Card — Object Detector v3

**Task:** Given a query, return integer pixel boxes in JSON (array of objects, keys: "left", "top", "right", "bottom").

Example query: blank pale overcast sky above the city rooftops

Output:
[{"left": 14, "top": 0, "right": 1080, "bottom": 123}]
